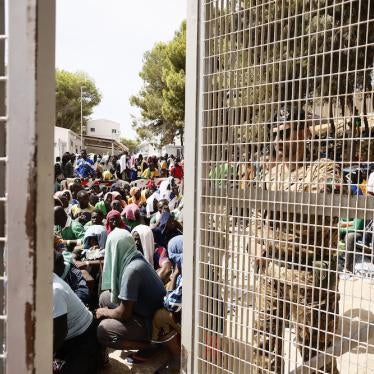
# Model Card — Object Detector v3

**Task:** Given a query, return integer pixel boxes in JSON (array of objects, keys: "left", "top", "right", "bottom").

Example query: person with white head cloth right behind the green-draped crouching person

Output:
[{"left": 131, "top": 225, "right": 172, "bottom": 283}]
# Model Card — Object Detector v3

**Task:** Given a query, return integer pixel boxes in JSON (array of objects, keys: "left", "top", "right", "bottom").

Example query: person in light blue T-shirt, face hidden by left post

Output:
[{"left": 53, "top": 253, "right": 99, "bottom": 374}]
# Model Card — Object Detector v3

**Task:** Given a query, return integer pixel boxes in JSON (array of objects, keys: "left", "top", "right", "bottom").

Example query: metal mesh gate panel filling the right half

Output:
[{"left": 190, "top": 0, "right": 374, "bottom": 373}]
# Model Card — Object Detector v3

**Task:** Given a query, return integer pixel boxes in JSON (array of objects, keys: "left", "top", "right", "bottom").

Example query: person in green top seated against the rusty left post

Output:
[{"left": 54, "top": 207, "right": 84, "bottom": 252}]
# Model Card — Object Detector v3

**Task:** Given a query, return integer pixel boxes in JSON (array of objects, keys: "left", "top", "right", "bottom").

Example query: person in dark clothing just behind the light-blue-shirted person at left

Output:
[{"left": 53, "top": 251, "right": 90, "bottom": 305}]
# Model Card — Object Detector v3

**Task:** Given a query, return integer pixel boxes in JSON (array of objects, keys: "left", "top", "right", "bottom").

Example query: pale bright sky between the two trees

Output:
[{"left": 56, "top": 0, "right": 187, "bottom": 138}]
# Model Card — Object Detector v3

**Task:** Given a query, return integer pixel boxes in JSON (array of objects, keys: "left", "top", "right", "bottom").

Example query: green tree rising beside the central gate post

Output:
[{"left": 130, "top": 22, "right": 186, "bottom": 145}]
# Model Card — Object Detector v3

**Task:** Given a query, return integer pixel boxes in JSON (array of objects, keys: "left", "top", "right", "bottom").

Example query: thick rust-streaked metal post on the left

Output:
[{"left": 5, "top": 0, "right": 55, "bottom": 373}]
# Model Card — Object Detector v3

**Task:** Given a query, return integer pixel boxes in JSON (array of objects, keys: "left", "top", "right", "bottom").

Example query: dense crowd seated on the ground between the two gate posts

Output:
[{"left": 53, "top": 150, "right": 183, "bottom": 374}]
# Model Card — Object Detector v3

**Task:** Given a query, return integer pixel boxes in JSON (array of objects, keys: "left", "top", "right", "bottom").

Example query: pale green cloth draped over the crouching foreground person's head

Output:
[{"left": 101, "top": 228, "right": 143, "bottom": 304}]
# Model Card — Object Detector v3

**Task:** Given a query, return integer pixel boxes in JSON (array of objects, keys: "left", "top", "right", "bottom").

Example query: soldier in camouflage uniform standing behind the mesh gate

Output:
[{"left": 252, "top": 107, "right": 341, "bottom": 373}]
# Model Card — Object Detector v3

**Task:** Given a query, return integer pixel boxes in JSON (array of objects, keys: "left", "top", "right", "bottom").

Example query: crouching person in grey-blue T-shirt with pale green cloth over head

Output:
[{"left": 96, "top": 228, "right": 165, "bottom": 349}]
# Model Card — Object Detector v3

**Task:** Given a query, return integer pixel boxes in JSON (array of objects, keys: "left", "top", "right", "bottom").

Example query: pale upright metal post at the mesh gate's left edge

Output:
[{"left": 181, "top": 1, "right": 201, "bottom": 373}]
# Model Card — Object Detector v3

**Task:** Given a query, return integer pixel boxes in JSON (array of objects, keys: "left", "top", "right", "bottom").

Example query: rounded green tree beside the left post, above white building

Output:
[{"left": 56, "top": 70, "right": 101, "bottom": 132}]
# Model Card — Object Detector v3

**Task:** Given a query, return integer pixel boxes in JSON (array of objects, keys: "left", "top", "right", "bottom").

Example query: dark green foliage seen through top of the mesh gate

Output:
[{"left": 209, "top": 0, "right": 374, "bottom": 141}]
